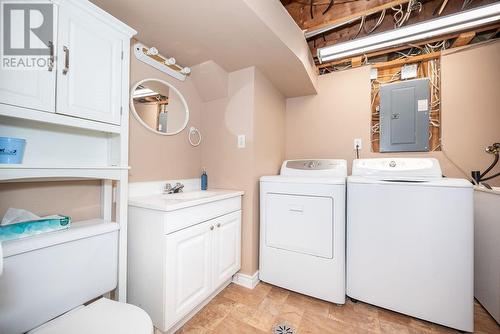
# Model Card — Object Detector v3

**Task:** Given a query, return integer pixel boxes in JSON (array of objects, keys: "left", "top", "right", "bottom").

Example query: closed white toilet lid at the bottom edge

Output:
[{"left": 29, "top": 298, "right": 153, "bottom": 334}]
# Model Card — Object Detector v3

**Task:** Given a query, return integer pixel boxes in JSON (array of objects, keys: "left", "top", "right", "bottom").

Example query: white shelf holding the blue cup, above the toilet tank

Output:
[{"left": 0, "top": 164, "right": 130, "bottom": 182}]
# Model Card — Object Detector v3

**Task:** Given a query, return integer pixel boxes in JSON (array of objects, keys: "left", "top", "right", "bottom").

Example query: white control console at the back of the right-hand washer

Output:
[{"left": 352, "top": 158, "right": 443, "bottom": 180}]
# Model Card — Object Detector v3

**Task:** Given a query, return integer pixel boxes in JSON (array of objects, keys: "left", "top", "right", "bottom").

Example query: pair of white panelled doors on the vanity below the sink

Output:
[{"left": 165, "top": 211, "right": 241, "bottom": 328}]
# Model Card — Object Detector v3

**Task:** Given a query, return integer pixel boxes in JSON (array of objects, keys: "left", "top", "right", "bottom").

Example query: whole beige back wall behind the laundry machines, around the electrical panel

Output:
[{"left": 286, "top": 43, "right": 500, "bottom": 184}]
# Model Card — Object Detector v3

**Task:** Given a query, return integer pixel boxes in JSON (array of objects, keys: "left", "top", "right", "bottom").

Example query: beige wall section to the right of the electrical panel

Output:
[{"left": 441, "top": 41, "right": 500, "bottom": 186}]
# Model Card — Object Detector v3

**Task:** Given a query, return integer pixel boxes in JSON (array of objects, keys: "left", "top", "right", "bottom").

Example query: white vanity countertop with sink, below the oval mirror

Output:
[{"left": 128, "top": 189, "right": 243, "bottom": 211}]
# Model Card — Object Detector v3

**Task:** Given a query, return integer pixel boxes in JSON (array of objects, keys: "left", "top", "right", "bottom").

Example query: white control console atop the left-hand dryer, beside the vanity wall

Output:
[{"left": 280, "top": 159, "right": 347, "bottom": 178}]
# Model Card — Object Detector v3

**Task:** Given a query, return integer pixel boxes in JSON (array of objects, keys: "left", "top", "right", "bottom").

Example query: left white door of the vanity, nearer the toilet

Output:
[{"left": 164, "top": 221, "right": 215, "bottom": 329}]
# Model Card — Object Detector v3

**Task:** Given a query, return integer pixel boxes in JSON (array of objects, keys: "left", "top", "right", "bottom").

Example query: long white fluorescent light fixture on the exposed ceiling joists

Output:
[{"left": 318, "top": 3, "right": 500, "bottom": 63}]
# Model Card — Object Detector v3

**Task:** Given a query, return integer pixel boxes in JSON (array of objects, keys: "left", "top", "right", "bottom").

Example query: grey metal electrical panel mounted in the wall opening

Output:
[{"left": 380, "top": 78, "right": 430, "bottom": 152}]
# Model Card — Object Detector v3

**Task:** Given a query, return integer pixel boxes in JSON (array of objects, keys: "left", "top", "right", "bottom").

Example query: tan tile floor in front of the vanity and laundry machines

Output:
[{"left": 177, "top": 283, "right": 500, "bottom": 334}]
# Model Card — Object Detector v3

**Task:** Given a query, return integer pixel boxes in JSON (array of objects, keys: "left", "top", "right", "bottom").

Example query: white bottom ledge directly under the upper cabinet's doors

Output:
[{"left": 0, "top": 103, "right": 122, "bottom": 134}]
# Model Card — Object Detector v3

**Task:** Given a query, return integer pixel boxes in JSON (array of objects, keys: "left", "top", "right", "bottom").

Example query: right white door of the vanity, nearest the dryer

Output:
[{"left": 212, "top": 211, "right": 241, "bottom": 289}]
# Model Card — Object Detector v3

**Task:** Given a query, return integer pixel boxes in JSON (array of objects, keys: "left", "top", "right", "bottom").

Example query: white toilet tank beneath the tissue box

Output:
[{"left": 0, "top": 220, "right": 119, "bottom": 334}]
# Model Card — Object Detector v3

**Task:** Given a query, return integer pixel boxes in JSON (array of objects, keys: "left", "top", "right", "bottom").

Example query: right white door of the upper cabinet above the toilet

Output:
[{"left": 57, "top": 2, "right": 122, "bottom": 124}]
